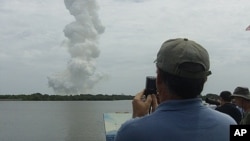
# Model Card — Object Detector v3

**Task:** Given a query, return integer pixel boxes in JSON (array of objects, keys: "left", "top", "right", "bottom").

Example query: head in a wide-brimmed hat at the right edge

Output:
[{"left": 231, "top": 87, "right": 250, "bottom": 110}]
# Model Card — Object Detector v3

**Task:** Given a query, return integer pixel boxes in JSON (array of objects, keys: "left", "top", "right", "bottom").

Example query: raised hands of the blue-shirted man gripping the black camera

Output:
[{"left": 132, "top": 91, "right": 158, "bottom": 118}]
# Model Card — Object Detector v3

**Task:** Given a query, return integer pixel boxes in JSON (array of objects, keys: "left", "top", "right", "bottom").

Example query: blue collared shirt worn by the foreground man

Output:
[{"left": 115, "top": 98, "right": 236, "bottom": 141}]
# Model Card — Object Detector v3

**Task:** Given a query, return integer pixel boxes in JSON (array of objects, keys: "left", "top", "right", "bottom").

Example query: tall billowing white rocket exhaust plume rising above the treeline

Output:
[{"left": 48, "top": 0, "right": 105, "bottom": 94}]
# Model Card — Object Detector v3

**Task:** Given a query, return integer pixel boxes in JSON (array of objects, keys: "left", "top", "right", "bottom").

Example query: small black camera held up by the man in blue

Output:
[{"left": 144, "top": 76, "right": 157, "bottom": 97}]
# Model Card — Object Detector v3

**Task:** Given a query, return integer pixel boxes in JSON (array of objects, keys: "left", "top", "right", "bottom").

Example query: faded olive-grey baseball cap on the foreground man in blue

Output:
[{"left": 155, "top": 38, "right": 211, "bottom": 78}]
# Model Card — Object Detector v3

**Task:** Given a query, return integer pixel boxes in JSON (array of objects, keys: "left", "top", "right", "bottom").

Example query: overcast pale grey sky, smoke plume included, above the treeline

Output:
[{"left": 0, "top": 0, "right": 250, "bottom": 95}]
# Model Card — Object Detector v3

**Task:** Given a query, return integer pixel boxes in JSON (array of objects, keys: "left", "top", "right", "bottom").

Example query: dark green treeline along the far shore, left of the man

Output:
[{"left": 0, "top": 93, "right": 134, "bottom": 101}]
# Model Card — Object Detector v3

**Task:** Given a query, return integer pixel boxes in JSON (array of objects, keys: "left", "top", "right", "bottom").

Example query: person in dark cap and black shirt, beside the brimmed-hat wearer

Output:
[{"left": 215, "top": 91, "right": 242, "bottom": 124}]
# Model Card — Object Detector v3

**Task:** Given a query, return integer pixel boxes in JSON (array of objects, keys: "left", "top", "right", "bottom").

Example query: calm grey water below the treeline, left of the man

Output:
[{"left": 0, "top": 100, "right": 132, "bottom": 141}]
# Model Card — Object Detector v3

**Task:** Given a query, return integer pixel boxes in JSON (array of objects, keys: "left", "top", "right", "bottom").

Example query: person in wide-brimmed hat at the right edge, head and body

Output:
[{"left": 232, "top": 87, "right": 250, "bottom": 125}]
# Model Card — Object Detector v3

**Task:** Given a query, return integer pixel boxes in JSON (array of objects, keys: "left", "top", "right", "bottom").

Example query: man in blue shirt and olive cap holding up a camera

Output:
[{"left": 115, "top": 38, "right": 236, "bottom": 141}]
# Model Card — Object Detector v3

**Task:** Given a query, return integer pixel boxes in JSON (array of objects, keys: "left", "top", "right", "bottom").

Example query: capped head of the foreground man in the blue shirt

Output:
[{"left": 155, "top": 38, "right": 211, "bottom": 101}]
